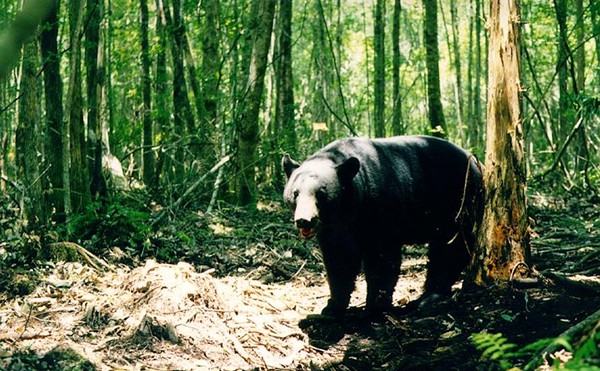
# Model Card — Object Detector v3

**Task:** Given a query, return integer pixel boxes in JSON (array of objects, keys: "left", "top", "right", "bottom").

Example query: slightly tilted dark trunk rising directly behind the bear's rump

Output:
[{"left": 423, "top": 0, "right": 447, "bottom": 137}]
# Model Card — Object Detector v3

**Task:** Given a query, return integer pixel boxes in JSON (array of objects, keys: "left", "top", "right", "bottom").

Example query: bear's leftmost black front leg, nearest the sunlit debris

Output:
[{"left": 321, "top": 245, "right": 361, "bottom": 317}]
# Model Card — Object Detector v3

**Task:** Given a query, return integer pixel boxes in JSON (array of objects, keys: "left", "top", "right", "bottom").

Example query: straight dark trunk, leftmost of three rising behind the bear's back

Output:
[{"left": 373, "top": 0, "right": 385, "bottom": 138}]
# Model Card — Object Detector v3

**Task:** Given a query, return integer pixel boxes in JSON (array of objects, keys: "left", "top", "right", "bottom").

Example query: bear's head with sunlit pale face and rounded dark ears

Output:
[{"left": 281, "top": 155, "right": 360, "bottom": 239}]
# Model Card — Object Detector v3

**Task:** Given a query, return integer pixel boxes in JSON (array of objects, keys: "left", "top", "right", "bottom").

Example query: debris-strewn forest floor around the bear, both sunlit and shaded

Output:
[{"left": 0, "top": 196, "right": 600, "bottom": 370}]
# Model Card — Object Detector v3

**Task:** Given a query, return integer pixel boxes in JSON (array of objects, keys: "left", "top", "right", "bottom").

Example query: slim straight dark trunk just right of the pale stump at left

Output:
[{"left": 140, "top": 0, "right": 156, "bottom": 189}]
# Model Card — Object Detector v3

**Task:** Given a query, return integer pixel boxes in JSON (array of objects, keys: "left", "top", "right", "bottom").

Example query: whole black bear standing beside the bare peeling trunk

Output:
[{"left": 282, "top": 136, "right": 483, "bottom": 315}]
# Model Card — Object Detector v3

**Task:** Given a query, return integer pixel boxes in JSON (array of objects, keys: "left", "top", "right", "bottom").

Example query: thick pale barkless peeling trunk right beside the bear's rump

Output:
[{"left": 469, "top": 0, "right": 530, "bottom": 285}]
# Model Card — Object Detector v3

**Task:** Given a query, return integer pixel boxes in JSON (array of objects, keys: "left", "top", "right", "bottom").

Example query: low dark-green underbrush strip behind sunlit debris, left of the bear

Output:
[{"left": 0, "top": 191, "right": 322, "bottom": 295}]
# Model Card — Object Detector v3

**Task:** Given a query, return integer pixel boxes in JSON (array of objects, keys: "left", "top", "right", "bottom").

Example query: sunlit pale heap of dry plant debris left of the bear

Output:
[{"left": 0, "top": 260, "right": 339, "bottom": 370}]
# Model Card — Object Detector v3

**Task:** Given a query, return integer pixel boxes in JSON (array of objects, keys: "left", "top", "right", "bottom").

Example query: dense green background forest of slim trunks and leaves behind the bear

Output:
[{"left": 0, "top": 0, "right": 600, "bottom": 225}]
